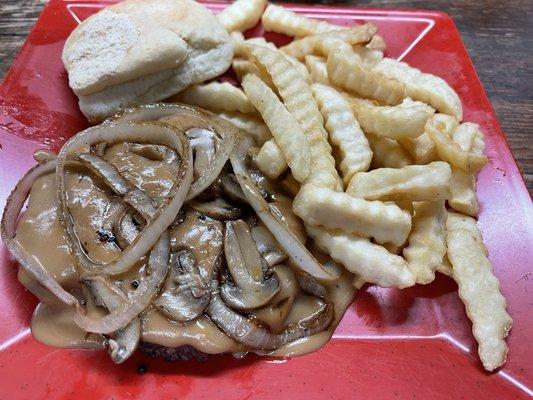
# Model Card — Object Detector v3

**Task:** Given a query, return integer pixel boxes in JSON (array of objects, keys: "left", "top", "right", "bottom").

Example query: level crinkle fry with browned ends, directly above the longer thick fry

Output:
[{"left": 346, "top": 161, "right": 452, "bottom": 201}]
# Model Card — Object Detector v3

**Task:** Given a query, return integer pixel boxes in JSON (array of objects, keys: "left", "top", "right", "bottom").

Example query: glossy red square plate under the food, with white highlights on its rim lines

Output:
[{"left": 0, "top": 0, "right": 533, "bottom": 399}]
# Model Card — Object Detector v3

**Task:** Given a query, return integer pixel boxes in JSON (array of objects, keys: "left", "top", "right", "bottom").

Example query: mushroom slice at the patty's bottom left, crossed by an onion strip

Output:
[{"left": 84, "top": 276, "right": 141, "bottom": 364}]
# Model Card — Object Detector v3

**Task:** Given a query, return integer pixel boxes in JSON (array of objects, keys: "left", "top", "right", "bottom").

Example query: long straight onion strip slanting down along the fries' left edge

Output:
[{"left": 230, "top": 140, "right": 336, "bottom": 281}]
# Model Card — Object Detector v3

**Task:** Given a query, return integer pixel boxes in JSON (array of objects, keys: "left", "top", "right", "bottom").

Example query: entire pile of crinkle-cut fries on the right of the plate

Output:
[{"left": 179, "top": 0, "right": 512, "bottom": 371}]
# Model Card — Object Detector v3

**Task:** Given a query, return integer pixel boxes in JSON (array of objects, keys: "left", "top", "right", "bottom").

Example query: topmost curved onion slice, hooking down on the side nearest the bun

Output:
[{"left": 106, "top": 103, "right": 239, "bottom": 200}]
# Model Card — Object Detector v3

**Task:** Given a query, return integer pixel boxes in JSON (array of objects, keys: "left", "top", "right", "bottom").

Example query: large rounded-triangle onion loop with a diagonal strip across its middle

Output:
[{"left": 56, "top": 122, "right": 193, "bottom": 275}]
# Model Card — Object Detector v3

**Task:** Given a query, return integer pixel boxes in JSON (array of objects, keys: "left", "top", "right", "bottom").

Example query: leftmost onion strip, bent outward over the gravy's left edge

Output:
[{"left": 1, "top": 159, "right": 78, "bottom": 306}]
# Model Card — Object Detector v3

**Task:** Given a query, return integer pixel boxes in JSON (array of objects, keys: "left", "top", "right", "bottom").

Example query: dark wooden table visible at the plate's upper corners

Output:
[{"left": 0, "top": 0, "right": 533, "bottom": 193}]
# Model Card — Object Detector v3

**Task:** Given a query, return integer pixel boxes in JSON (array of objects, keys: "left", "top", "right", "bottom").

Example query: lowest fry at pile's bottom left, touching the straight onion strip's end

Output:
[{"left": 306, "top": 224, "right": 415, "bottom": 288}]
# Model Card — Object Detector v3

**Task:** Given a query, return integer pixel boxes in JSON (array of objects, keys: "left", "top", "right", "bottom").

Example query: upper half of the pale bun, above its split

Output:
[{"left": 62, "top": 0, "right": 232, "bottom": 96}]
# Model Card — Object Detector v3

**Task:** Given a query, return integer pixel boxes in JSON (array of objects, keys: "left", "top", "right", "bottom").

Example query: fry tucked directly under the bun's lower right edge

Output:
[{"left": 170, "top": 82, "right": 255, "bottom": 114}]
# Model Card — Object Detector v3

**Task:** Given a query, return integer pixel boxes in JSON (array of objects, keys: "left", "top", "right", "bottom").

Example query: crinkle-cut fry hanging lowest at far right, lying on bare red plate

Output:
[{"left": 446, "top": 213, "right": 513, "bottom": 371}]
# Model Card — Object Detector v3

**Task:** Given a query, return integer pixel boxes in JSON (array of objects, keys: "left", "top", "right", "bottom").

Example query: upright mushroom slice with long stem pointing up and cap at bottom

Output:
[{"left": 220, "top": 220, "right": 280, "bottom": 310}]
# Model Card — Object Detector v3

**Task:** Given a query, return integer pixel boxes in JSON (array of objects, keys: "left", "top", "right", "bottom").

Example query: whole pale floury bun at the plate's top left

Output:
[{"left": 62, "top": 0, "right": 233, "bottom": 122}]
